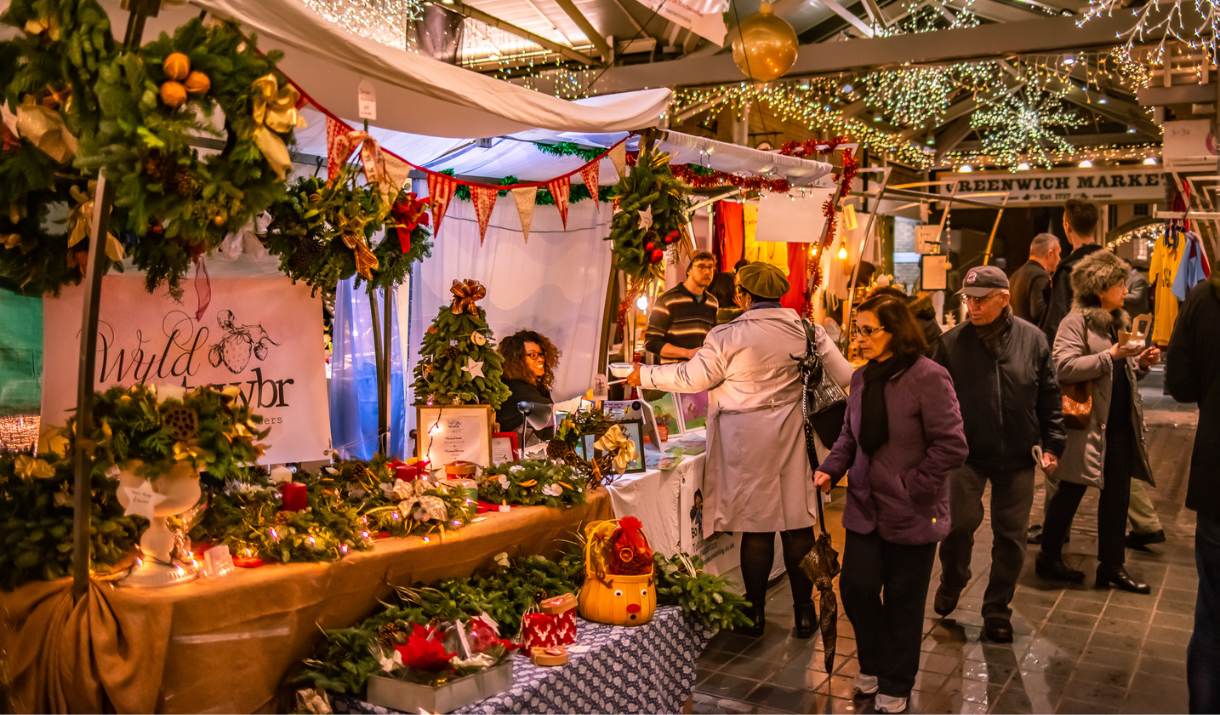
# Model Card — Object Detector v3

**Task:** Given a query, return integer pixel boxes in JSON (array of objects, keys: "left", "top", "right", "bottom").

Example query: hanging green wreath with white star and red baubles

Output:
[{"left": 606, "top": 149, "right": 689, "bottom": 284}]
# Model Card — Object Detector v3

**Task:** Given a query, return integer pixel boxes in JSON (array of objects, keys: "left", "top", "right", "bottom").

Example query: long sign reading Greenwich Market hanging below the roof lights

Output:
[{"left": 939, "top": 166, "right": 1165, "bottom": 206}]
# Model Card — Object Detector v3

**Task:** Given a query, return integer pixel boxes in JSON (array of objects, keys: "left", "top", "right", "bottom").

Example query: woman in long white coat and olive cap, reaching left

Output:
[{"left": 628, "top": 264, "right": 852, "bottom": 638}]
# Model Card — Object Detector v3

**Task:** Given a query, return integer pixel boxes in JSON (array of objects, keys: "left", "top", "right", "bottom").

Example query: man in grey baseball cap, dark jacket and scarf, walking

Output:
[{"left": 933, "top": 266, "right": 1068, "bottom": 643}]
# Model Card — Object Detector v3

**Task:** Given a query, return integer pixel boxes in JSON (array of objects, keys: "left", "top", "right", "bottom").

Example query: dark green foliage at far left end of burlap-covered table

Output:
[{"left": 0, "top": 451, "right": 144, "bottom": 591}]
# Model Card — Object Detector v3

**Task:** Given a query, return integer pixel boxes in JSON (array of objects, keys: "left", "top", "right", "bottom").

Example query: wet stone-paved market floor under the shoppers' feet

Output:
[{"left": 694, "top": 371, "right": 1198, "bottom": 713}]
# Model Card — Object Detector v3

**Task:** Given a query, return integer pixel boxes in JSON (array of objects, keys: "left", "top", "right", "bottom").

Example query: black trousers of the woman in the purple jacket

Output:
[{"left": 839, "top": 531, "right": 936, "bottom": 698}]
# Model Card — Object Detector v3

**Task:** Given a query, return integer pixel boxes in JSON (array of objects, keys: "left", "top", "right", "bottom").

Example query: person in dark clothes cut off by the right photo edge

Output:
[{"left": 1165, "top": 273, "right": 1220, "bottom": 713}]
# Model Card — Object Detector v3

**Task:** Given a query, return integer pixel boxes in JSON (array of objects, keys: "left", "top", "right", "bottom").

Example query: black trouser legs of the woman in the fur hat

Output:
[{"left": 1042, "top": 417, "right": 1136, "bottom": 566}]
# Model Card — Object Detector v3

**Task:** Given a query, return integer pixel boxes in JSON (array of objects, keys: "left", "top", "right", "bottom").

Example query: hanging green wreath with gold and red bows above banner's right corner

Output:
[{"left": 262, "top": 165, "right": 432, "bottom": 295}]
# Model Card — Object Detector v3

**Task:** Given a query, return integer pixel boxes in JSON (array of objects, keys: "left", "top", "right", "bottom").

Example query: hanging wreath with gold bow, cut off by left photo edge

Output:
[{"left": 0, "top": 0, "right": 123, "bottom": 294}]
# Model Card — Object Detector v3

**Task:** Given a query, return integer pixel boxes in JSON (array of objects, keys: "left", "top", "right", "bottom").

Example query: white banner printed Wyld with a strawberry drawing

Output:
[{"left": 43, "top": 275, "right": 331, "bottom": 464}]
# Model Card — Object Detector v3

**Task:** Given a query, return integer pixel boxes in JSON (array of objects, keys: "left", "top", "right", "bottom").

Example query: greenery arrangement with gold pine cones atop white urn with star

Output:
[{"left": 61, "top": 384, "right": 270, "bottom": 480}]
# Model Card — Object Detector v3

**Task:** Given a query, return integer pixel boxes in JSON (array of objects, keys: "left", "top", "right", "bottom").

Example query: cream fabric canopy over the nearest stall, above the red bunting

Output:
[{"left": 93, "top": 0, "right": 670, "bottom": 137}]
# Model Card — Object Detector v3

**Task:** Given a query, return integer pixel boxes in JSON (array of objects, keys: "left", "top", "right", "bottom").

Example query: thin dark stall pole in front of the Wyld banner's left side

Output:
[{"left": 72, "top": 0, "right": 161, "bottom": 600}]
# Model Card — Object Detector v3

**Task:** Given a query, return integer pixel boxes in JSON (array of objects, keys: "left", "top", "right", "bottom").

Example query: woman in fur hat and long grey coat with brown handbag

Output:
[{"left": 1036, "top": 250, "right": 1160, "bottom": 593}]
